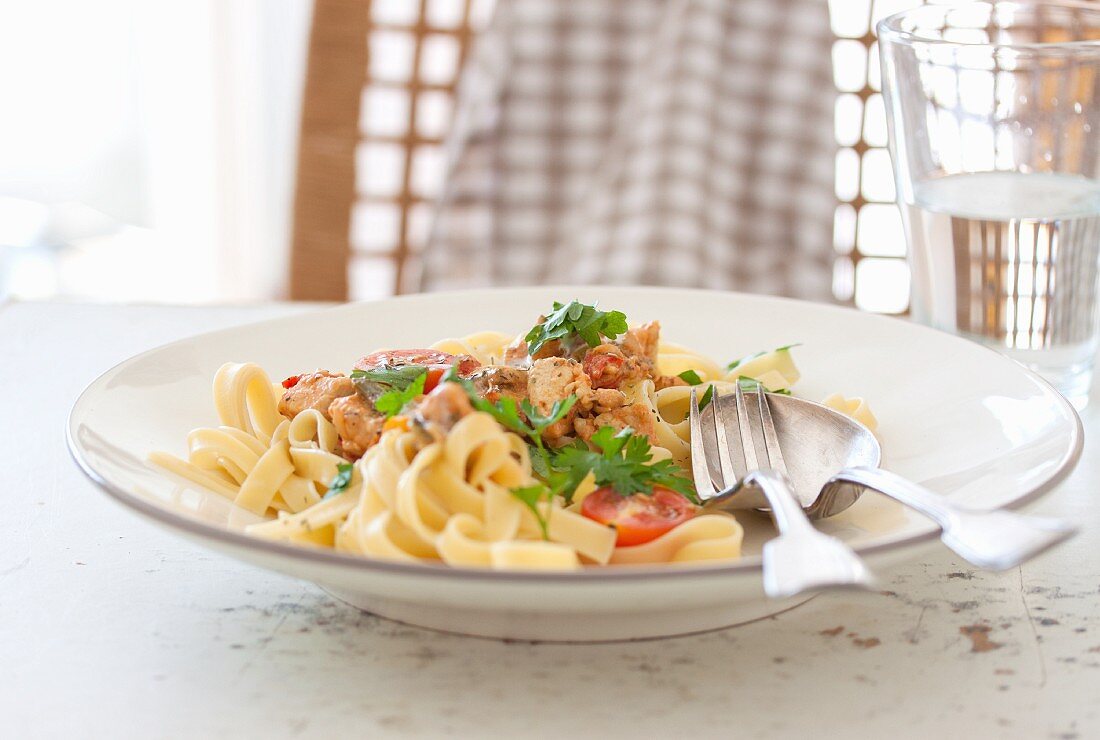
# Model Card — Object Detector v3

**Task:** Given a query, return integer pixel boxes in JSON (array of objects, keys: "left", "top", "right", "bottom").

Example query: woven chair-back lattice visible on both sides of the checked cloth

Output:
[{"left": 349, "top": 0, "right": 921, "bottom": 313}]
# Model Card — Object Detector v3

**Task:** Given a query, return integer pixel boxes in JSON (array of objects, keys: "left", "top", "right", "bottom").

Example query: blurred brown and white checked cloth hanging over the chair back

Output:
[{"left": 409, "top": 0, "right": 836, "bottom": 300}]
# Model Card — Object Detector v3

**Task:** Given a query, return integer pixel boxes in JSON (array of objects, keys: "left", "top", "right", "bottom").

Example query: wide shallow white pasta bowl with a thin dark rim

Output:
[{"left": 67, "top": 287, "right": 1082, "bottom": 641}]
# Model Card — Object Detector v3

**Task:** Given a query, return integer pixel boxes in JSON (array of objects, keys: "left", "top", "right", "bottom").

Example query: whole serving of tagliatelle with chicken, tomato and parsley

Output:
[{"left": 151, "top": 303, "right": 873, "bottom": 570}]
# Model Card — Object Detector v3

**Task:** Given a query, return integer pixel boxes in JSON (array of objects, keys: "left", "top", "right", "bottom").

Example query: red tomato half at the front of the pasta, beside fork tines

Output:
[{"left": 581, "top": 486, "right": 695, "bottom": 548}]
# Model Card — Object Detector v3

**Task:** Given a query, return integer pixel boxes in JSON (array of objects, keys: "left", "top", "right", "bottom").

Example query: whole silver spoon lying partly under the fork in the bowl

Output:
[{"left": 705, "top": 393, "right": 1076, "bottom": 571}]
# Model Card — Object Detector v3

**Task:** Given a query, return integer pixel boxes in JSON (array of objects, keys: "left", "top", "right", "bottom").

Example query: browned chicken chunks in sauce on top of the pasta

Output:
[{"left": 278, "top": 307, "right": 686, "bottom": 460}]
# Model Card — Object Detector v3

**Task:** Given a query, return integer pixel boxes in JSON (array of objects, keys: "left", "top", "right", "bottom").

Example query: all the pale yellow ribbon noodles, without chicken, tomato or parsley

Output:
[{"left": 150, "top": 316, "right": 873, "bottom": 570}]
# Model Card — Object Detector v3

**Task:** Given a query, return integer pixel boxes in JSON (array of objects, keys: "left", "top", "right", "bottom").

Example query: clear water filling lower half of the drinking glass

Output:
[{"left": 903, "top": 172, "right": 1100, "bottom": 398}]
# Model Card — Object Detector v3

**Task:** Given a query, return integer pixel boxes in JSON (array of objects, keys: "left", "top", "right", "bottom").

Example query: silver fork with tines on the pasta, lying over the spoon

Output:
[{"left": 689, "top": 383, "right": 873, "bottom": 598}]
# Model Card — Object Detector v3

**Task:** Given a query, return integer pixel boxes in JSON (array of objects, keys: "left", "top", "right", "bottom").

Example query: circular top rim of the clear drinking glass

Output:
[{"left": 875, "top": 0, "right": 1100, "bottom": 56}]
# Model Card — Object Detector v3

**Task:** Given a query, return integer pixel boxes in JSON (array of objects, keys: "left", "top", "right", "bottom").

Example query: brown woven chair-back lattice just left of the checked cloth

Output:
[{"left": 349, "top": 0, "right": 494, "bottom": 298}]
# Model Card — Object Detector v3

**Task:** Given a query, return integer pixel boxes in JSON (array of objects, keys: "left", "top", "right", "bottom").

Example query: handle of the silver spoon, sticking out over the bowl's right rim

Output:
[{"left": 831, "top": 467, "right": 1076, "bottom": 571}]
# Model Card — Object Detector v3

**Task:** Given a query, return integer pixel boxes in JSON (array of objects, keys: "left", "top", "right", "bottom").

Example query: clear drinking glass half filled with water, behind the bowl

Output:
[{"left": 878, "top": 1, "right": 1100, "bottom": 407}]
